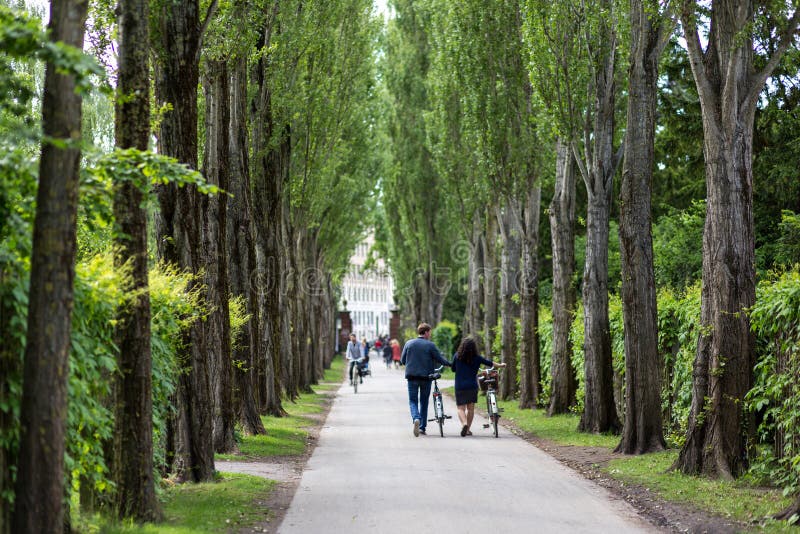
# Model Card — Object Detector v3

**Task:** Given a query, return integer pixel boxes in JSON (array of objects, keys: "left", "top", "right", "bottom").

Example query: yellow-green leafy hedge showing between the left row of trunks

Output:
[{"left": 0, "top": 254, "right": 203, "bottom": 510}]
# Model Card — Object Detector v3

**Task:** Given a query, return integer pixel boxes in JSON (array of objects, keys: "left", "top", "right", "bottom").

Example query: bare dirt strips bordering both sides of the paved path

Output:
[{"left": 231, "top": 391, "right": 752, "bottom": 534}]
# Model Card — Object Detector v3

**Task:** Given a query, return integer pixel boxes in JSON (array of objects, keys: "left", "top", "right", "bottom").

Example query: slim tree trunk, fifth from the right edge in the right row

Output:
[{"left": 519, "top": 182, "right": 542, "bottom": 408}]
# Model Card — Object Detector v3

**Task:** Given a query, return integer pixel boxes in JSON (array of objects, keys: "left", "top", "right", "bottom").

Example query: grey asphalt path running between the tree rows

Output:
[{"left": 278, "top": 358, "right": 655, "bottom": 534}]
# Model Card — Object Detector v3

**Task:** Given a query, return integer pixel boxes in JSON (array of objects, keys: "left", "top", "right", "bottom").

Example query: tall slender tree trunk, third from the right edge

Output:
[{"left": 576, "top": 12, "right": 620, "bottom": 432}]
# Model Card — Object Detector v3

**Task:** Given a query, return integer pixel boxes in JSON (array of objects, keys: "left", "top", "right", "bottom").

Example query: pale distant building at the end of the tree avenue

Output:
[{"left": 340, "top": 234, "right": 394, "bottom": 343}]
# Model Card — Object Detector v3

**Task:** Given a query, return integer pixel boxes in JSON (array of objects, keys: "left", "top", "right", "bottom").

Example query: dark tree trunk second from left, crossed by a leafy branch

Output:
[{"left": 111, "top": 0, "right": 160, "bottom": 522}]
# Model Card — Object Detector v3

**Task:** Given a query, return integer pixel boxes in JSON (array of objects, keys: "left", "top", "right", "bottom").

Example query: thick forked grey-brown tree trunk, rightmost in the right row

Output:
[{"left": 673, "top": 0, "right": 800, "bottom": 479}]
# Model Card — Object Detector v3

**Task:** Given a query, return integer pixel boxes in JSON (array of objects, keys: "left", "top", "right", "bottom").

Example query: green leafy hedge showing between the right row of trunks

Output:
[{"left": 539, "top": 266, "right": 800, "bottom": 492}]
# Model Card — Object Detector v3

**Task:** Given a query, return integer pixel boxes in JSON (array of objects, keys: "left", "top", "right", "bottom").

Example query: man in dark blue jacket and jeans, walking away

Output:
[{"left": 400, "top": 323, "right": 451, "bottom": 436}]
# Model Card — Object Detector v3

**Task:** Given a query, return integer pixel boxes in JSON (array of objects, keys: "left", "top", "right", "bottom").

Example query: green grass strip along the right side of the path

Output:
[{"left": 490, "top": 399, "right": 797, "bottom": 532}]
